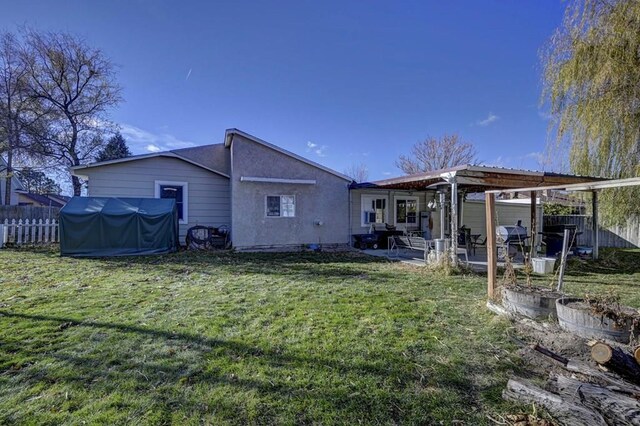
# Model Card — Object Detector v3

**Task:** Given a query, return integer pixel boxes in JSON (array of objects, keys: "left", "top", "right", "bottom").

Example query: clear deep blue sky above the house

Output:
[{"left": 0, "top": 0, "right": 564, "bottom": 179}]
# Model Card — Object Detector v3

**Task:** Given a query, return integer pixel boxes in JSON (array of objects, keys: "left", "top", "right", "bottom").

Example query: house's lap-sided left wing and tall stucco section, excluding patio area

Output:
[{"left": 72, "top": 129, "right": 352, "bottom": 250}]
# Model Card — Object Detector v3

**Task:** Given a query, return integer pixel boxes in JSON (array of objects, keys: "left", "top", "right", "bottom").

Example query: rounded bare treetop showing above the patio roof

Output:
[{"left": 396, "top": 133, "right": 478, "bottom": 175}]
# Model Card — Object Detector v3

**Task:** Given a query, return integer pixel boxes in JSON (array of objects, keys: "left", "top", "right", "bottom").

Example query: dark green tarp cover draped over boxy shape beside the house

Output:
[{"left": 60, "top": 197, "right": 178, "bottom": 257}]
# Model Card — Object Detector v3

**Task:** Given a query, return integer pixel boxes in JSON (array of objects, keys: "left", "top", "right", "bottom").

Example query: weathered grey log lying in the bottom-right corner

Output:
[{"left": 552, "top": 375, "right": 640, "bottom": 425}]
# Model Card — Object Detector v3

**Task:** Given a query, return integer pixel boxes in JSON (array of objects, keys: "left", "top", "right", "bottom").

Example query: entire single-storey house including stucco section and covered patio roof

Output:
[{"left": 72, "top": 129, "right": 604, "bottom": 250}]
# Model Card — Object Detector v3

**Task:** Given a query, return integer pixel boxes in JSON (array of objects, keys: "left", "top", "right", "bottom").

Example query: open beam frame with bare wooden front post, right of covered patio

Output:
[{"left": 485, "top": 177, "right": 640, "bottom": 299}]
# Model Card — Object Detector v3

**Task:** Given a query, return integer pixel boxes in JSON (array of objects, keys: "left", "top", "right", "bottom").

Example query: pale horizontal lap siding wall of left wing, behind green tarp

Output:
[{"left": 82, "top": 157, "right": 231, "bottom": 242}]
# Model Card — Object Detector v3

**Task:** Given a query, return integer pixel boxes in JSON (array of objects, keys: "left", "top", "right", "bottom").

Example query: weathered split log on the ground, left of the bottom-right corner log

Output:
[{"left": 502, "top": 379, "right": 606, "bottom": 426}]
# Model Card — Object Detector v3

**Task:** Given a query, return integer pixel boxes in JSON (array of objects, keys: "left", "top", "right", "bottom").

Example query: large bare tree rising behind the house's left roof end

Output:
[{"left": 24, "top": 30, "right": 121, "bottom": 195}]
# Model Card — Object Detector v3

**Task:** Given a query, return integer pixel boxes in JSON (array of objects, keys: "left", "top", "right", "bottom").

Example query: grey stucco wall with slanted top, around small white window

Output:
[{"left": 231, "top": 135, "right": 349, "bottom": 250}]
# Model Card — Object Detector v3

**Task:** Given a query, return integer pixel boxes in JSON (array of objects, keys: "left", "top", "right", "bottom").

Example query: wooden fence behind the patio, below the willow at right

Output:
[{"left": 543, "top": 215, "right": 640, "bottom": 248}]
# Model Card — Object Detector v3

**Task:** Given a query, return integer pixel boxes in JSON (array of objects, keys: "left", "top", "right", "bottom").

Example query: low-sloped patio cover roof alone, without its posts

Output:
[{"left": 351, "top": 164, "right": 606, "bottom": 192}]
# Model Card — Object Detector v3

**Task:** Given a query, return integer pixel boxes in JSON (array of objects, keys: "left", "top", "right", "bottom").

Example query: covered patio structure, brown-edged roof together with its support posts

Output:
[{"left": 352, "top": 164, "right": 605, "bottom": 262}]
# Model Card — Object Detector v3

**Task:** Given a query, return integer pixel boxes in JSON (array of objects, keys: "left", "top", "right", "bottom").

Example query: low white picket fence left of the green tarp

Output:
[{"left": 0, "top": 219, "right": 60, "bottom": 247}]
